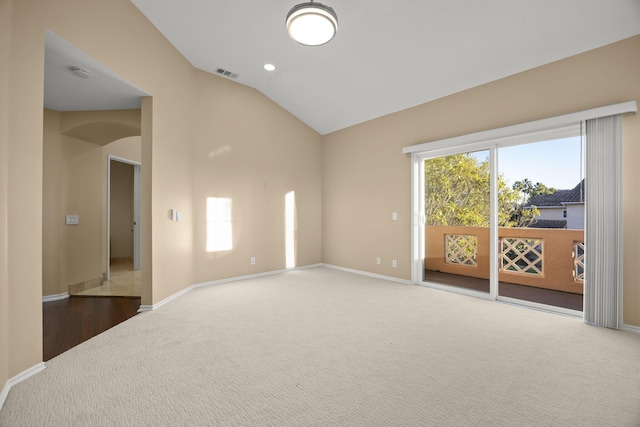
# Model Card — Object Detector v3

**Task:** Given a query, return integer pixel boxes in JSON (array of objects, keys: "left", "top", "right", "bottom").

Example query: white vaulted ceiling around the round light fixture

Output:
[{"left": 45, "top": 0, "right": 640, "bottom": 134}]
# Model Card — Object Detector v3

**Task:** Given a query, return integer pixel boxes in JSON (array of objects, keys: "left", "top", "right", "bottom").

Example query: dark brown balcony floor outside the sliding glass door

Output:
[{"left": 424, "top": 270, "right": 583, "bottom": 311}]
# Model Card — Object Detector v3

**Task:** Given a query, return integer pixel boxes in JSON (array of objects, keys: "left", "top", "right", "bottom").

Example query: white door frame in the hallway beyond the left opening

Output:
[{"left": 105, "top": 154, "right": 140, "bottom": 280}]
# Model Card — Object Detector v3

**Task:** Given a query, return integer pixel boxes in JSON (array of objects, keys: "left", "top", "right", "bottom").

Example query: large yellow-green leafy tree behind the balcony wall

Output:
[{"left": 424, "top": 153, "right": 521, "bottom": 227}]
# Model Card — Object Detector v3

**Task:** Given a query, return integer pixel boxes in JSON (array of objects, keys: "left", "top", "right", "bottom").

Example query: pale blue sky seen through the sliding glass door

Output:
[{"left": 474, "top": 137, "right": 584, "bottom": 190}]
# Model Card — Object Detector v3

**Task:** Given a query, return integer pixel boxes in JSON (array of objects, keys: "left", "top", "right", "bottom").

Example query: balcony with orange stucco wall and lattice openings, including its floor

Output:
[{"left": 424, "top": 225, "right": 584, "bottom": 311}]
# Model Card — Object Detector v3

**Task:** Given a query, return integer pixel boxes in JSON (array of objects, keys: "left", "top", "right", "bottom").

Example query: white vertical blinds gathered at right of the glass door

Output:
[{"left": 584, "top": 114, "right": 622, "bottom": 329}]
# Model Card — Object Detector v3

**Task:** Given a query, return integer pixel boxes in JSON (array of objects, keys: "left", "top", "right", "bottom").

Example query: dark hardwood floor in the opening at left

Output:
[{"left": 42, "top": 296, "right": 140, "bottom": 361}]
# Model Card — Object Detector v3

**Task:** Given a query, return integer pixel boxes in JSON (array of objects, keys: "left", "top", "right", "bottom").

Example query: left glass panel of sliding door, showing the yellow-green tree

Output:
[{"left": 423, "top": 150, "right": 491, "bottom": 294}]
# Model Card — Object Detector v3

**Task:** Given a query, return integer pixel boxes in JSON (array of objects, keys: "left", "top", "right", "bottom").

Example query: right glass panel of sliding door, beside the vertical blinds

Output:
[{"left": 497, "top": 137, "right": 585, "bottom": 311}]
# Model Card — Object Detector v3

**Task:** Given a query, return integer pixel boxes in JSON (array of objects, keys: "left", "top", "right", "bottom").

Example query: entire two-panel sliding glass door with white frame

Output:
[{"left": 414, "top": 128, "right": 585, "bottom": 314}]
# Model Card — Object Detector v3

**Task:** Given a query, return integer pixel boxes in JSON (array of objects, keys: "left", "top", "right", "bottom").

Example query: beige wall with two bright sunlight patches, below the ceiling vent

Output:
[{"left": 193, "top": 72, "right": 322, "bottom": 282}]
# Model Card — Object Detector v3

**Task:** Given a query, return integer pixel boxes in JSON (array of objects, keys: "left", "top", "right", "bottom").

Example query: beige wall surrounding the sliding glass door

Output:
[{"left": 323, "top": 36, "right": 640, "bottom": 326}]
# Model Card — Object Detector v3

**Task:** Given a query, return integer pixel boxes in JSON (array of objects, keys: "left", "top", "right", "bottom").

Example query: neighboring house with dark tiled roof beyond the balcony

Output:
[{"left": 525, "top": 179, "right": 585, "bottom": 230}]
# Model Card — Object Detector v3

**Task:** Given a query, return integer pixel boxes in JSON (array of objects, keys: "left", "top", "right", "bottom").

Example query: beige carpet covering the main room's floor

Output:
[{"left": 0, "top": 268, "right": 640, "bottom": 427}]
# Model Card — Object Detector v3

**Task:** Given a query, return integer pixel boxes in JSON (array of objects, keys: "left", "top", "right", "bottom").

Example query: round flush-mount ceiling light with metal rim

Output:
[{"left": 287, "top": 1, "right": 338, "bottom": 46}]
